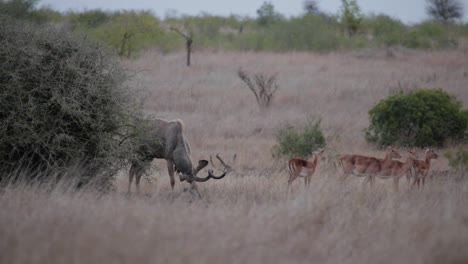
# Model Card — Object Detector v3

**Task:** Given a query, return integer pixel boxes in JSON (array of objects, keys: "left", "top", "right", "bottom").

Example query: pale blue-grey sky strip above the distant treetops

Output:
[{"left": 39, "top": 0, "right": 468, "bottom": 24}]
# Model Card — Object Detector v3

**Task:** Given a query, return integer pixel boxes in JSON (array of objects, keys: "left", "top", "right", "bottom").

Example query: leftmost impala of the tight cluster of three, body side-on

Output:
[{"left": 340, "top": 147, "right": 401, "bottom": 186}]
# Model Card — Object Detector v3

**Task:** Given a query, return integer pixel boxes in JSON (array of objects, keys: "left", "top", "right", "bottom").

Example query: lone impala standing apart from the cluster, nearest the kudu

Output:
[{"left": 288, "top": 149, "right": 324, "bottom": 191}]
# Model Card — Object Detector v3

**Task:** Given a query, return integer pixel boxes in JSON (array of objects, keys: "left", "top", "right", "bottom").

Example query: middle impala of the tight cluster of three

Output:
[{"left": 366, "top": 149, "right": 418, "bottom": 191}]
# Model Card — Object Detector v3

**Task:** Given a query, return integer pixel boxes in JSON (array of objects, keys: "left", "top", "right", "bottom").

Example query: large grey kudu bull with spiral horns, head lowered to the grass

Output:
[{"left": 128, "top": 119, "right": 227, "bottom": 197}]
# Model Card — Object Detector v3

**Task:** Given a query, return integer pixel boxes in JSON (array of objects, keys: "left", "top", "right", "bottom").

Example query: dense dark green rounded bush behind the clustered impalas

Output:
[{"left": 365, "top": 89, "right": 468, "bottom": 147}]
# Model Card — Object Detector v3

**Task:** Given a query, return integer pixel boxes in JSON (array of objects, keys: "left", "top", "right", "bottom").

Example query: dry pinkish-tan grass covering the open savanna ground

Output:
[{"left": 0, "top": 48, "right": 468, "bottom": 263}]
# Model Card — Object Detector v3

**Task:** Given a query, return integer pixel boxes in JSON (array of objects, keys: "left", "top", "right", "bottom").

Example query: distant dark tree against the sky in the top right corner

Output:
[{"left": 426, "top": 0, "right": 463, "bottom": 23}]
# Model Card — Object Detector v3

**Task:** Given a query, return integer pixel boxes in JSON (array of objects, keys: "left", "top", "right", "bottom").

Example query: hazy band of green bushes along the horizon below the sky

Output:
[{"left": 0, "top": 0, "right": 468, "bottom": 54}]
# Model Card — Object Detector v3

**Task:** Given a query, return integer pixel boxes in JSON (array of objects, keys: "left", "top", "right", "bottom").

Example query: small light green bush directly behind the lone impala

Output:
[{"left": 272, "top": 120, "right": 326, "bottom": 158}]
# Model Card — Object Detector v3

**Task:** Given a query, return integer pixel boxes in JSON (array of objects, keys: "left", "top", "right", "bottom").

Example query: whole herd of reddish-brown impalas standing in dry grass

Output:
[{"left": 288, "top": 147, "right": 438, "bottom": 191}]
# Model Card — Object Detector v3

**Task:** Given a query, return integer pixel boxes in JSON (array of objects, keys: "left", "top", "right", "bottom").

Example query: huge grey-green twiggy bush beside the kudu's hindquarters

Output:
[{"left": 0, "top": 19, "right": 138, "bottom": 186}]
